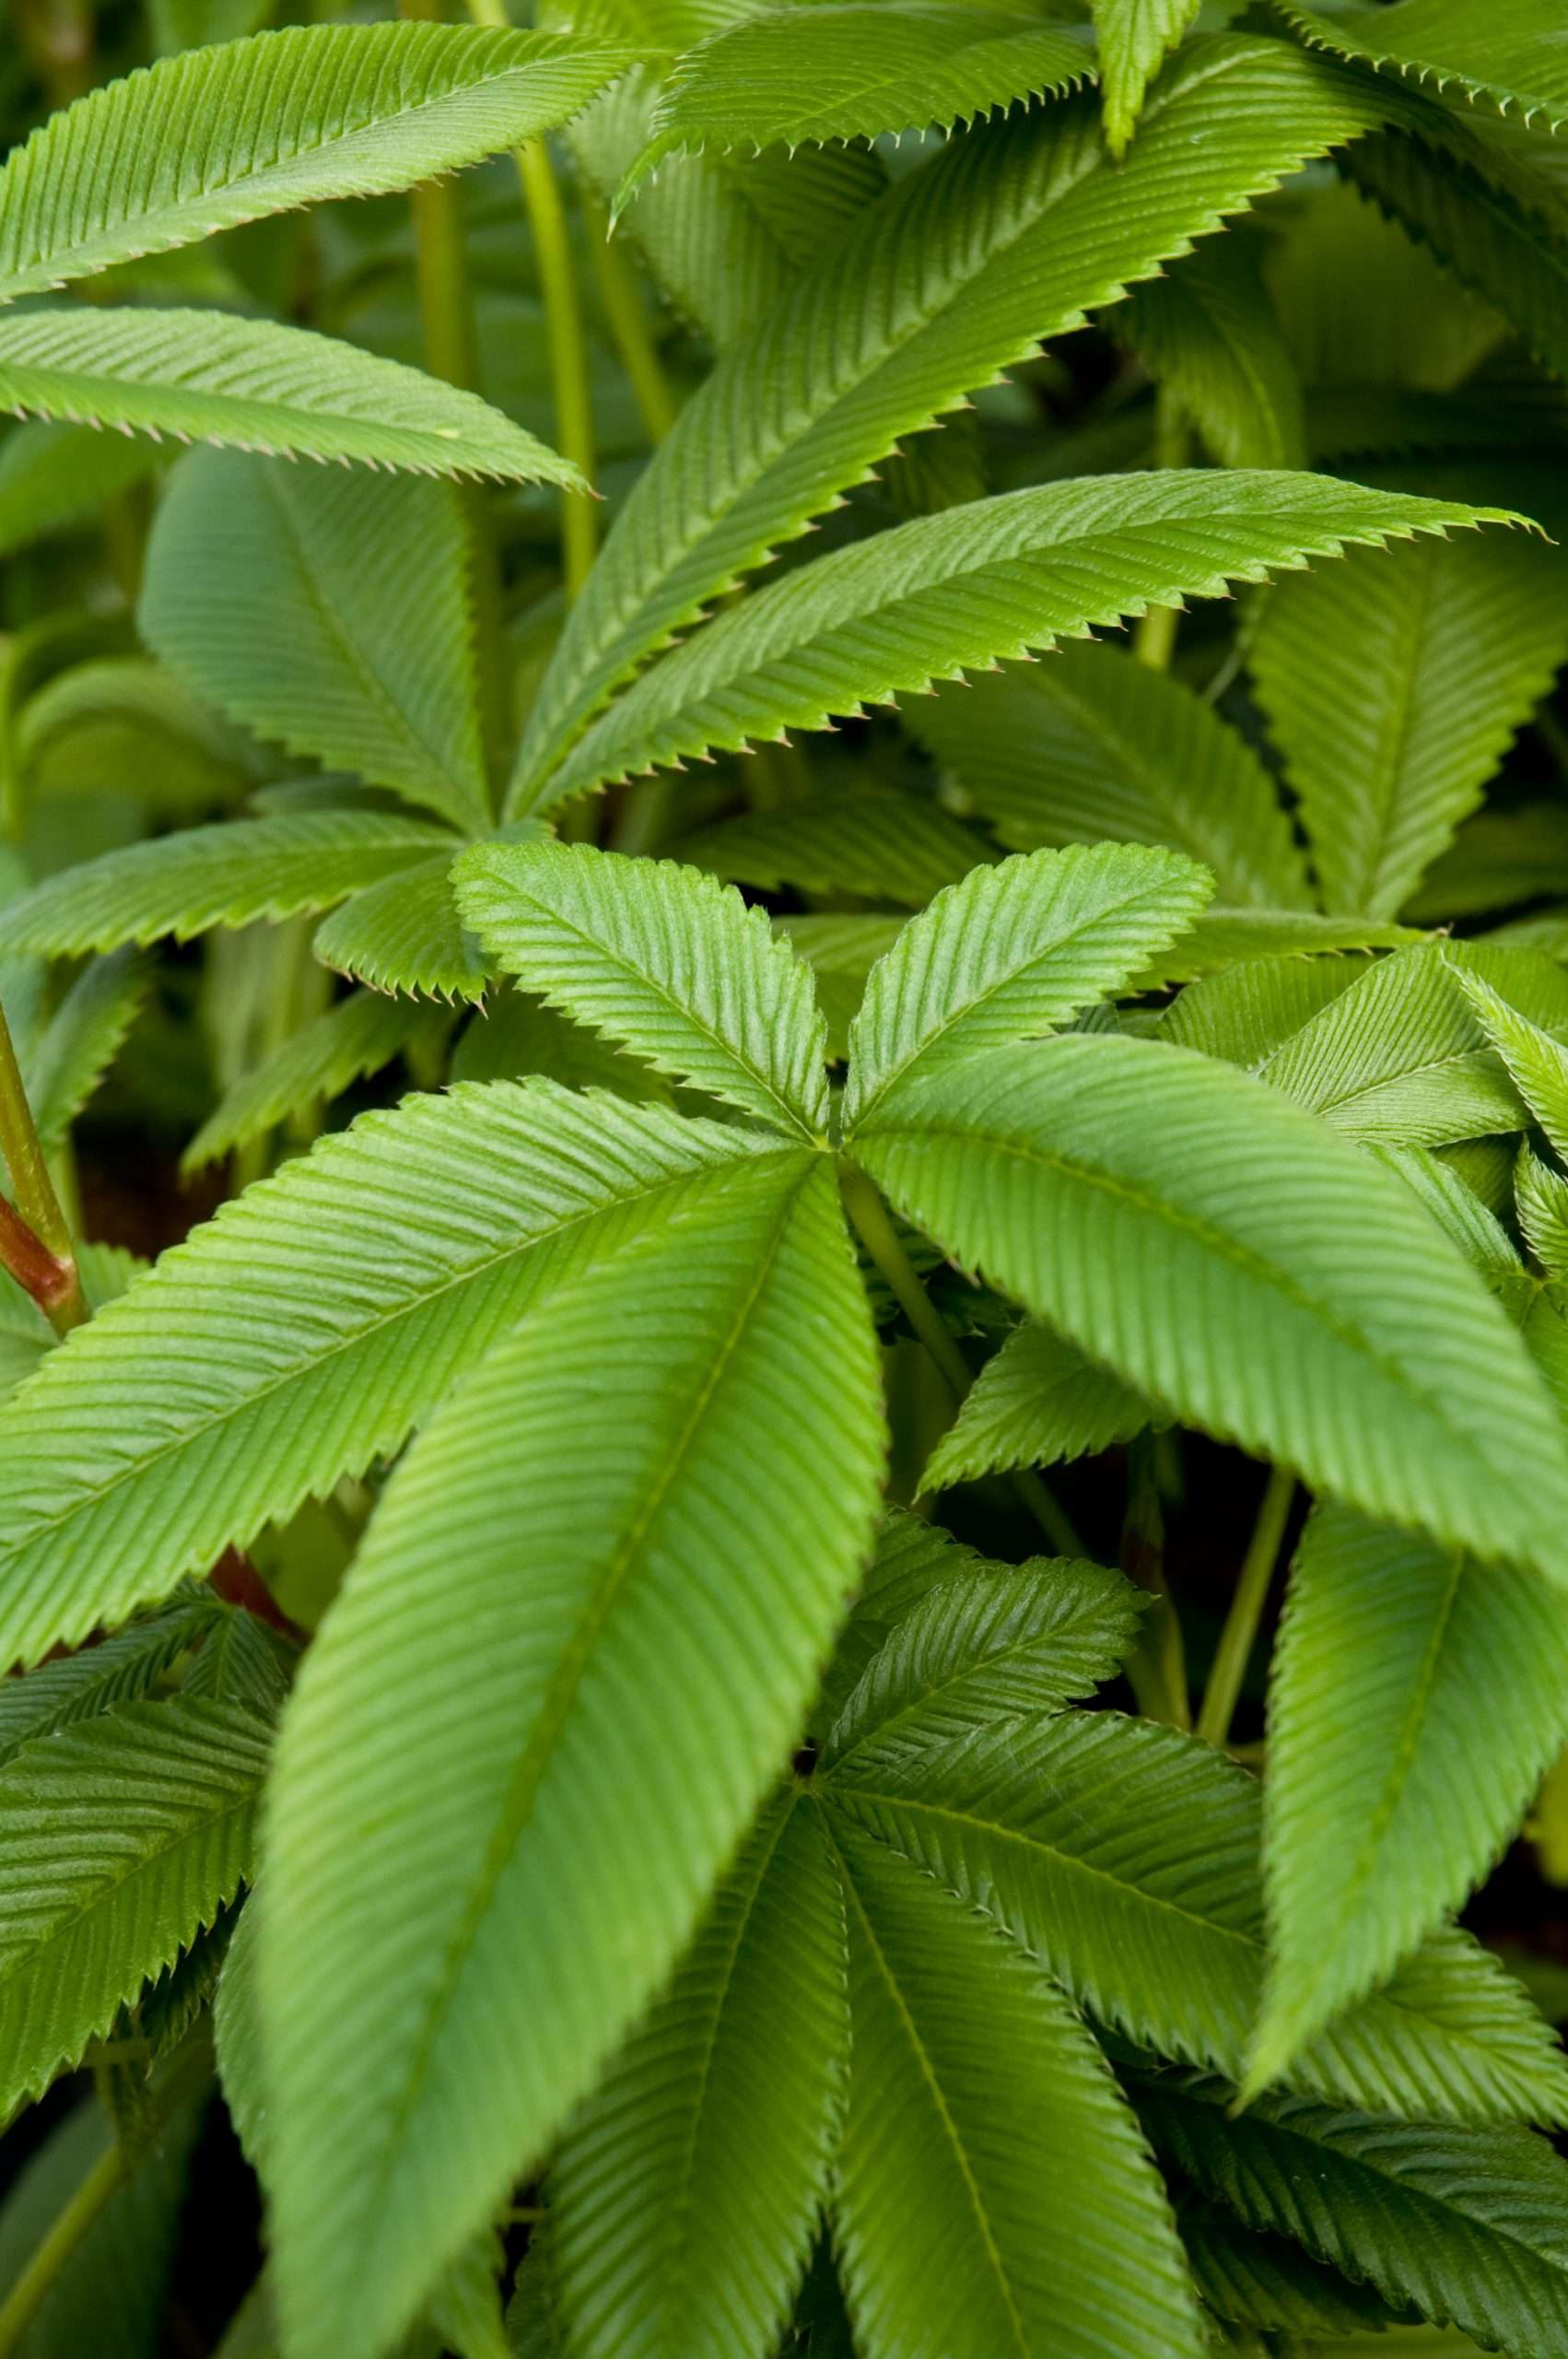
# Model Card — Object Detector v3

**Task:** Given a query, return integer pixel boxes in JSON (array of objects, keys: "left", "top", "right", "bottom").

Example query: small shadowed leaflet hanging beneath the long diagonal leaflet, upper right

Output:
[{"left": 1113, "top": 236, "right": 1306, "bottom": 467}]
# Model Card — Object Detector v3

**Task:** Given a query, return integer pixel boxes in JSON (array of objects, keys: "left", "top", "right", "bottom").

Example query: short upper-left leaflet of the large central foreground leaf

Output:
[{"left": 455, "top": 844, "right": 827, "bottom": 1137}]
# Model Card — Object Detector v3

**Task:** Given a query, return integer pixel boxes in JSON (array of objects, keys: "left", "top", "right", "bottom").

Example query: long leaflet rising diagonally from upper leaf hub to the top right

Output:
[{"left": 511, "top": 38, "right": 1398, "bottom": 809}]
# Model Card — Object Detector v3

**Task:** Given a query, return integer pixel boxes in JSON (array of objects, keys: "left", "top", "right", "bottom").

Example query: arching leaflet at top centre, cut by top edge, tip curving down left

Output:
[{"left": 618, "top": 0, "right": 1094, "bottom": 205}]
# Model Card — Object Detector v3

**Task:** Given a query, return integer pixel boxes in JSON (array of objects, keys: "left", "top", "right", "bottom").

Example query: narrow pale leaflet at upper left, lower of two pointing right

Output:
[{"left": 0, "top": 304, "right": 582, "bottom": 490}]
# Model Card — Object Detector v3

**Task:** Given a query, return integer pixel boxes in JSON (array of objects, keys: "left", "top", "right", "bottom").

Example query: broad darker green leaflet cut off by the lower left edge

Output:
[{"left": 0, "top": 1701, "right": 271, "bottom": 2114}]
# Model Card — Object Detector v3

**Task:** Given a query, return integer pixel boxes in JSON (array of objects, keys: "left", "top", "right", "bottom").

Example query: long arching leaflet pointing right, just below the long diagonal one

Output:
[{"left": 544, "top": 469, "right": 1506, "bottom": 804}]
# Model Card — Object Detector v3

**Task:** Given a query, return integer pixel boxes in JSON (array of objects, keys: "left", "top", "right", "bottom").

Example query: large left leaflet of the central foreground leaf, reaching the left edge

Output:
[{"left": 0, "top": 1080, "right": 780, "bottom": 1663}]
